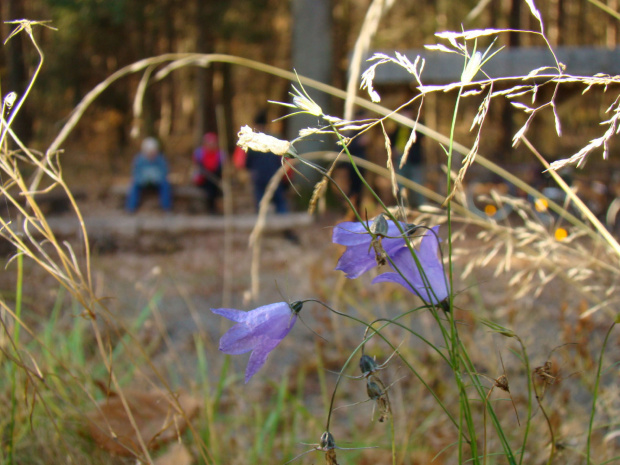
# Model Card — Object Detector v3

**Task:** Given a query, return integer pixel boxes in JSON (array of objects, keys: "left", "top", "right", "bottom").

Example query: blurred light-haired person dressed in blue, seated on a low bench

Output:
[{"left": 125, "top": 137, "right": 172, "bottom": 213}]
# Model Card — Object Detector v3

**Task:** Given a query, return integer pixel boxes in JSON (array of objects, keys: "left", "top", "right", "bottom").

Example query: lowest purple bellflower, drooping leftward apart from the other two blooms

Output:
[{"left": 211, "top": 302, "right": 303, "bottom": 383}]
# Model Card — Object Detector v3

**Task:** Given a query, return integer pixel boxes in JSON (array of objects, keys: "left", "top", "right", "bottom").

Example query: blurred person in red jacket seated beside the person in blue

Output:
[{"left": 193, "top": 132, "right": 224, "bottom": 213}]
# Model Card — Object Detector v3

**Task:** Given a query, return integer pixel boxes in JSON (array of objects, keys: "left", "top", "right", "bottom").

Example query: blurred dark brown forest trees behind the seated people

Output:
[{"left": 0, "top": 0, "right": 619, "bottom": 189}]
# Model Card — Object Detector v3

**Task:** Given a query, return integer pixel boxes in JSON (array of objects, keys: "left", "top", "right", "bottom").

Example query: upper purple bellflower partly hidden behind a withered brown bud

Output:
[{"left": 332, "top": 220, "right": 408, "bottom": 279}]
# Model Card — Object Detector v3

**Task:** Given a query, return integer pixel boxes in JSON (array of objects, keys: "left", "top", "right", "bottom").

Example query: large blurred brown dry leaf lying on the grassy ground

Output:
[{"left": 86, "top": 389, "right": 199, "bottom": 455}]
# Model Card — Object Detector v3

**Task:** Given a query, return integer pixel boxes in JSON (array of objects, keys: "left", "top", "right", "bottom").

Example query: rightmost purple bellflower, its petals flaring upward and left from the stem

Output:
[{"left": 372, "top": 226, "right": 450, "bottom": 307}]
